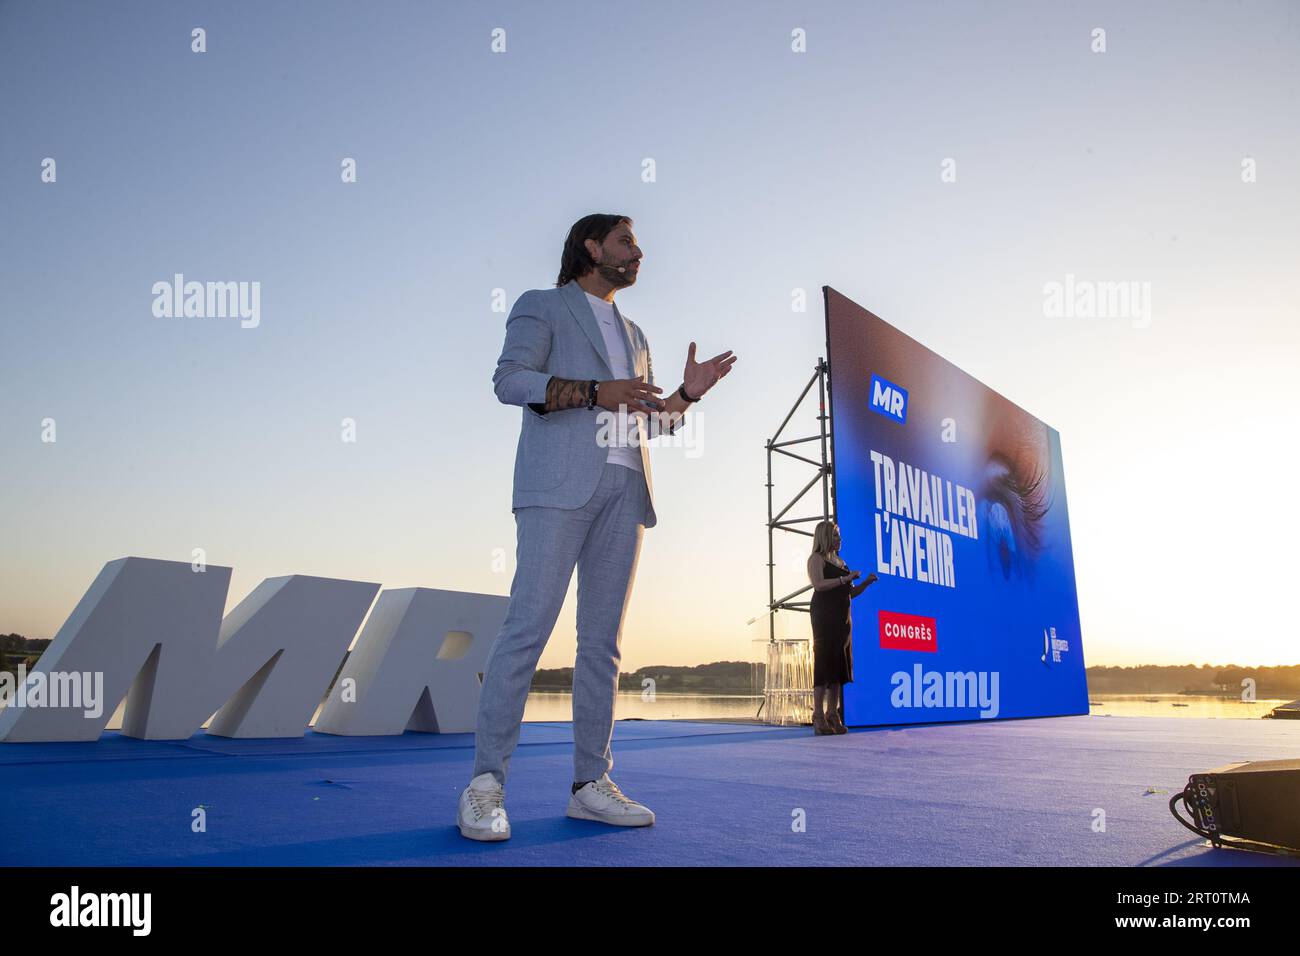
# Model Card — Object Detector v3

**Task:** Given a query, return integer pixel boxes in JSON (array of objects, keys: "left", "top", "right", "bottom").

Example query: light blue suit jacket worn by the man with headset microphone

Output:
[{"left": 491, "top": 280, "right": 658, "bottom": 528}]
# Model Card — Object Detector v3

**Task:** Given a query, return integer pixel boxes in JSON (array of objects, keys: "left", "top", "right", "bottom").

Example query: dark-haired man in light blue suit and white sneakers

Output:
[{"left": 456, "top": 213, "right": 736, "bottom": 840}]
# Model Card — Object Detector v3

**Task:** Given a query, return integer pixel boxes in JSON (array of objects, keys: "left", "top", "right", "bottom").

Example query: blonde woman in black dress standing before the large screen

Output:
[{"left": 809, "top": 520, "right": 878, "bottom": 734}]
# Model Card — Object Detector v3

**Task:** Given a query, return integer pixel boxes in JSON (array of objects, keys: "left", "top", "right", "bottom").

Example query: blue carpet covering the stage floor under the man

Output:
[{"left": 0, "top": 717, "right": 1300, "bottom": 866}]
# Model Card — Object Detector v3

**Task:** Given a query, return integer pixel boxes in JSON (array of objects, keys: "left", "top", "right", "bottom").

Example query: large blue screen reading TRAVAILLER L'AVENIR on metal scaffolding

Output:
[{"left": 819, "top": 286, "right": 1088, "bottom": 726}]
